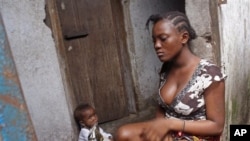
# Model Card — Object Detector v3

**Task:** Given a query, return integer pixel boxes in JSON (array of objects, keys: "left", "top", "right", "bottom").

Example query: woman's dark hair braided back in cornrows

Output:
[{"left": 146, "top": 11, "right": 197, "bottom": 42}]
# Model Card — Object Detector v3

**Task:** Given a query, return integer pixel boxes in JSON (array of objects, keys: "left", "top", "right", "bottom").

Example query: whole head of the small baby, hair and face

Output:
[{"left": 74, "top": 104, "right": 98, "bottom": 128}]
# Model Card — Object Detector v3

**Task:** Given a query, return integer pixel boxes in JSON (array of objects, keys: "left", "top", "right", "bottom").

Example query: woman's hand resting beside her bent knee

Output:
[{"left": 141, "top": 118, "right": 169, "bottom": 141}]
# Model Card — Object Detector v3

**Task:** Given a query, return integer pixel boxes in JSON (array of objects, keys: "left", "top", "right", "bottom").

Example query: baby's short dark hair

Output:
[{"left": 74, "top": 103, "right": 93, "bottom": 129}]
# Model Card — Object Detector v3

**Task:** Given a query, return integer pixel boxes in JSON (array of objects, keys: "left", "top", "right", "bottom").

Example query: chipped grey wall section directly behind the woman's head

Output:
[{"left": 186, "top": 0, "right": 217, "bottom": 63}]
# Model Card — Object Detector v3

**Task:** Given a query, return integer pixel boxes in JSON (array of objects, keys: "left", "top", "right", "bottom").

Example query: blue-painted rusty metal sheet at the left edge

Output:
[{"left": 0, "top": 15, "right": 37, "bottom": 141}]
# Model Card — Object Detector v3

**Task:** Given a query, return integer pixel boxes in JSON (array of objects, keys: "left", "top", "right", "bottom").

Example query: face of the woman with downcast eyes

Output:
[{"left": 152, "top": 20, "right": 183, "bottom": 62}]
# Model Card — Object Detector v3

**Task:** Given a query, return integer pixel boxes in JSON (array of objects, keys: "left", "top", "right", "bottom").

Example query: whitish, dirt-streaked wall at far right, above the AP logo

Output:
[{"left": 219, "top": 0, "right": 250, "bottom": 141}]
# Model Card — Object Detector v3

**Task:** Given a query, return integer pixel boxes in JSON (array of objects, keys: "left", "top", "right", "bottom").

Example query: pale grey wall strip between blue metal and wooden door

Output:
[{"left": 0, "top": 0, "right": 73, "bottom": 141}]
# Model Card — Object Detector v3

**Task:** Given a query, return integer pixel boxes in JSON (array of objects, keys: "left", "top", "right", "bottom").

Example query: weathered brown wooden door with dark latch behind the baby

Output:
[{"left": 53, "top": 0, "right": 128, "bottom": 122}]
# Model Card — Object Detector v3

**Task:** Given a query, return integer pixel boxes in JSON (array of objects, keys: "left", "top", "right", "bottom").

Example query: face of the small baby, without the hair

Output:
[{"left": 83, "top": 108, "right": 98, "bottom": 128}]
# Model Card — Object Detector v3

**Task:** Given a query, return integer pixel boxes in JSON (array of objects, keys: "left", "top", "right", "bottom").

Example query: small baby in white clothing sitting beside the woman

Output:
[{"left": 74, "top": 104, "right": 112, "bottom": 141}]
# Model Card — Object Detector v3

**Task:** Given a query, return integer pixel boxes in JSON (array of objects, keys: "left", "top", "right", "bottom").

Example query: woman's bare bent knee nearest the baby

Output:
[{"left": 115, "top": 122, "right": 147, "bottom": 141}]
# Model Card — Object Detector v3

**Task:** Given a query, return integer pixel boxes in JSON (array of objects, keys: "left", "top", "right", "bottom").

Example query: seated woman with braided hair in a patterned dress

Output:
[{"left": 116, "top": 11, "right": 225, "bottom": 141}]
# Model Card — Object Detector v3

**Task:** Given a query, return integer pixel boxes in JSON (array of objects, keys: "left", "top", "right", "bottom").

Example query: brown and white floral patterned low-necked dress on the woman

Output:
[{"left": 158, "top": 59, "right": 226, "bottom": 141}]
